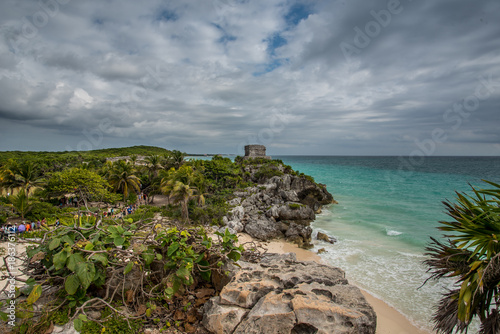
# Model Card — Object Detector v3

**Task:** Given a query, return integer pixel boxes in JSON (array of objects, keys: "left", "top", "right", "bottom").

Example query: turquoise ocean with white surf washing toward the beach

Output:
[{"left": 273, "top": 156, "right": 500, "bottom": 332}]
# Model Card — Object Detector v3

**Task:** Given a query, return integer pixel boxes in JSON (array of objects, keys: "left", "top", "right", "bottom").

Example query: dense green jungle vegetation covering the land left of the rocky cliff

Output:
[{"left": 0, "top": 146, "right": 306, "bottom": 334}]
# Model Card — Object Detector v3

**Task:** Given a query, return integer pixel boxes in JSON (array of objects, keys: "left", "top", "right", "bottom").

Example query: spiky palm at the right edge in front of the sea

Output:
[{"left": 425, "top": 181, "right": 500, "bottom": 334}]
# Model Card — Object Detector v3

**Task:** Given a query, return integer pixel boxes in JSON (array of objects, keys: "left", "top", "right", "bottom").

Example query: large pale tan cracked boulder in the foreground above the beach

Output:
[{"left": 203, "top": 253, "right": 376, "bottom": 334}]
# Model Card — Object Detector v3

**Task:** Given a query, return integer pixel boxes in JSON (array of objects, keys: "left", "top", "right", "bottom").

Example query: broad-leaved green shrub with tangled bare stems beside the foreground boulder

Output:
[{"left": 16, "top": 221, "right": 243, "bottom": 333}]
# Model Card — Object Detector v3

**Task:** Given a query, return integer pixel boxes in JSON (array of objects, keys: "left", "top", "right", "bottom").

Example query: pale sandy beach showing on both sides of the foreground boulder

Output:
[{"left": 238, "top": 233, "right": 432, "bottom": 334}]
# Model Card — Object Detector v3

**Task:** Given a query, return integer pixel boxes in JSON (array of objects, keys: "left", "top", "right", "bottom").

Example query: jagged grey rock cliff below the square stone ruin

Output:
[{"left": 223, "top": 165, "right": 335, "bottom": 248}]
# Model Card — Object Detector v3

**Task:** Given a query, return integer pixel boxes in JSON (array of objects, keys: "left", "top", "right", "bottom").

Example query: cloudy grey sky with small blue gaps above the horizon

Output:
[{"left": 0, "top": 0, "right": 500, "bottom": 156}]
